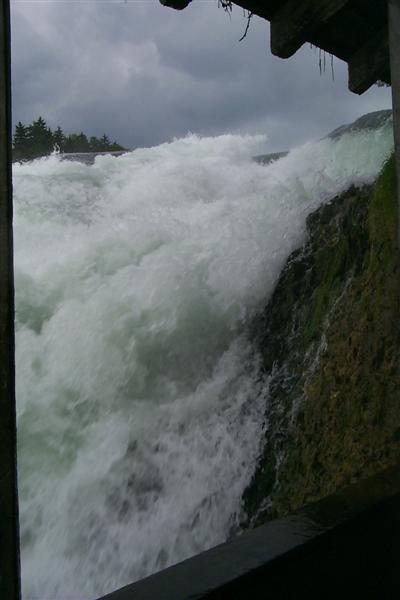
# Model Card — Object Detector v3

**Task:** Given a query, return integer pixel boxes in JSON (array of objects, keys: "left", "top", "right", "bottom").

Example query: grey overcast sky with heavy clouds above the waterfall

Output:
[{"left": 11, "top": 0, "right": 391, "bottom": 151}]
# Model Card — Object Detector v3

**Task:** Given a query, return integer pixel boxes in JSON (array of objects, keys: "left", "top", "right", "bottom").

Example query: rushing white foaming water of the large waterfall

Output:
[{"left": 14, "top": 126, "right": 392, "bottom": 600}]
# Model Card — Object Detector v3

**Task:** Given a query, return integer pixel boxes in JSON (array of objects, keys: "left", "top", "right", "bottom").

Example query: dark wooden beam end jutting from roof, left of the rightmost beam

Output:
[{"left": 271, "top": 0, "right": 348, "bottom": 58}]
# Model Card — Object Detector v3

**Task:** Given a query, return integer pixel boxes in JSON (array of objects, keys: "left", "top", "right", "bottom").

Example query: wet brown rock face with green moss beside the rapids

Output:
[{"left": 244, "top": 160, "right": 400, "bottom": 525}]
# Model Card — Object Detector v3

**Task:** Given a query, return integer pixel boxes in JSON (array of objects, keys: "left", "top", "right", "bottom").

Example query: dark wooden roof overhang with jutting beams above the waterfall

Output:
[{"left": 160, "top": 0, "right": 390, "bottom": 94}]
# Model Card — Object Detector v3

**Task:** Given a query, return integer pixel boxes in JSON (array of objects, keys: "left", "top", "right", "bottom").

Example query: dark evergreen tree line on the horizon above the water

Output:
[{"left": 13, "top": 117, "right": 126, "bottom": 160}]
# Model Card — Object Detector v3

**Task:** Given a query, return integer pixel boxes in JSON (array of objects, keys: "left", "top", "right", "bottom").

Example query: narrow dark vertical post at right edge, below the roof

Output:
[{"left": 388, "top": 0, "right": 400, "bottom": 248}]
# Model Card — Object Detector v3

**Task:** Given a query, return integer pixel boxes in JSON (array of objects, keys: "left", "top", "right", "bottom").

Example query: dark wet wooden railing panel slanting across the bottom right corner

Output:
[{"left": 103, "top": 467, "right": 400, "bottom": 600}]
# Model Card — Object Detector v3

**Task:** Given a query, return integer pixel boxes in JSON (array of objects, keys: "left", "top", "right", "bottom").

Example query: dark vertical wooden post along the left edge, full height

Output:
[{"left": 0, "top": 0, "right": 20, "bottom": 600}]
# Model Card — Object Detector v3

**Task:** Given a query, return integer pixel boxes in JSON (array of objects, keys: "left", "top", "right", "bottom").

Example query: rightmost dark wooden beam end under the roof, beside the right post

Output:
[{"left": 348, "top": 27, "right": 389, "bottom": 94}]
